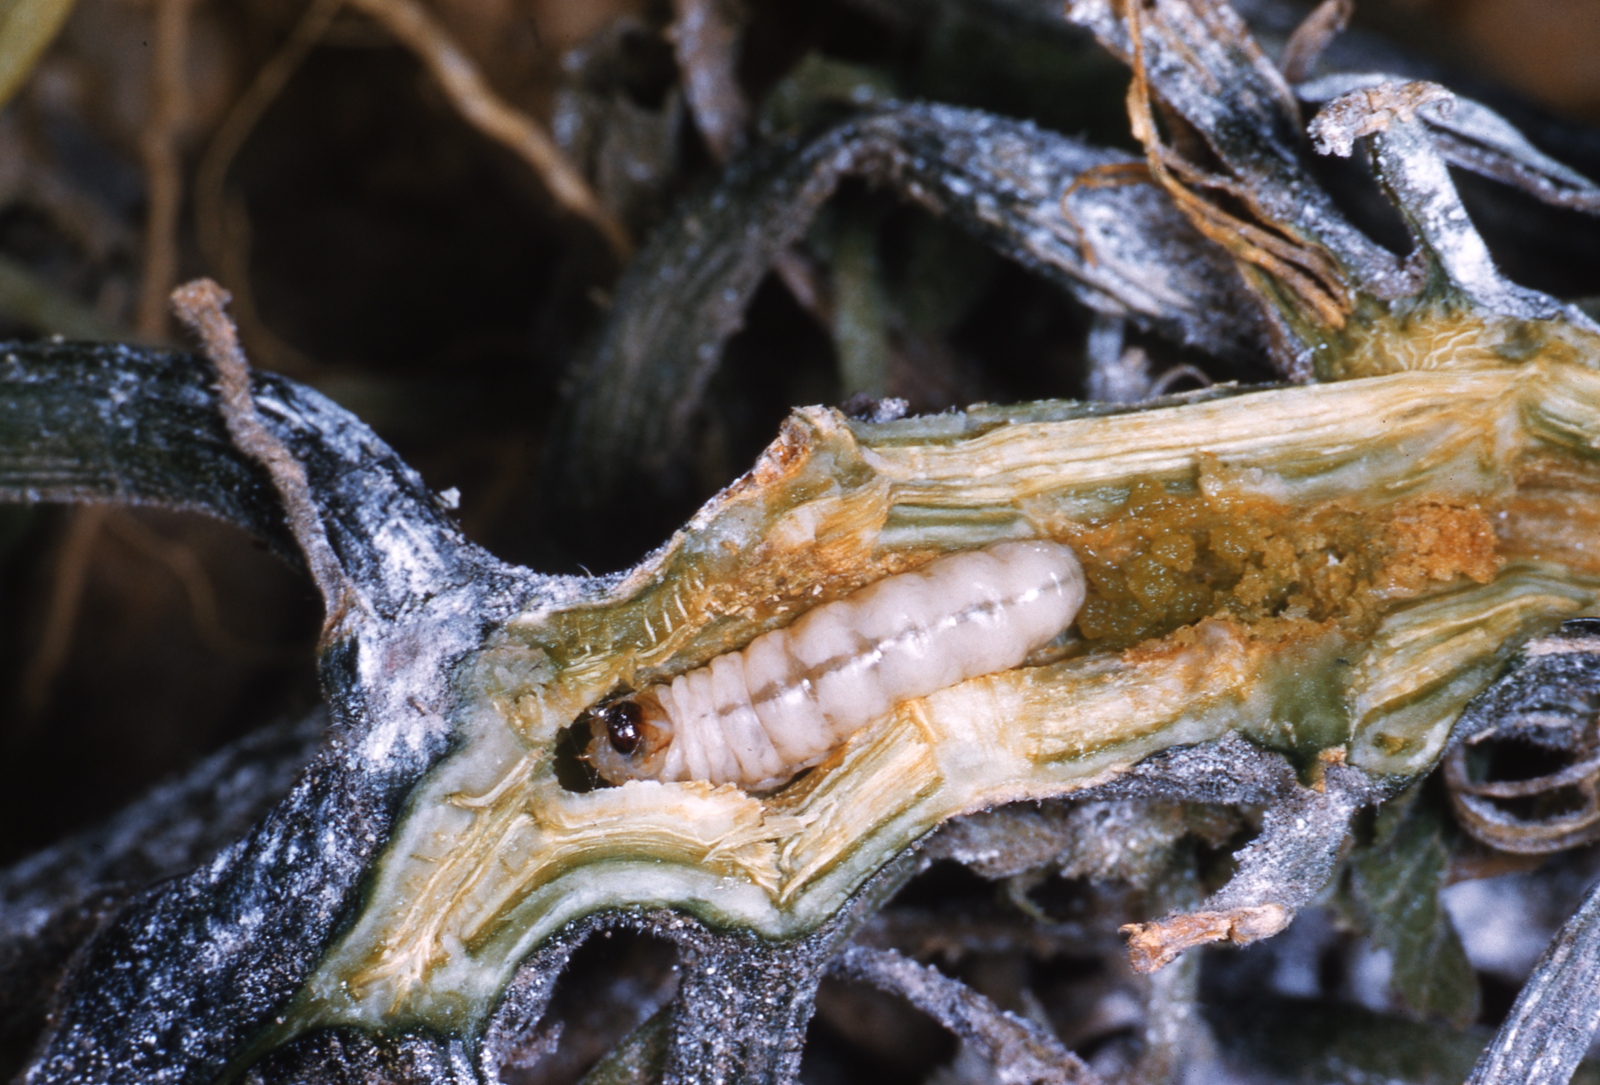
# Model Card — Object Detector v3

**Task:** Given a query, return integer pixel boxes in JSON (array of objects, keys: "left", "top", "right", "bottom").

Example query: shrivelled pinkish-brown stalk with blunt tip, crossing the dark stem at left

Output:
[{"left": 173, "top": 278, "right": 355, "bottom": 629}]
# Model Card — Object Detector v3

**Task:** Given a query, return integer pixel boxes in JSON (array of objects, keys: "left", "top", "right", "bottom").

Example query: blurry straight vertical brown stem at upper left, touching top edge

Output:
[{"left": 136, "top": 0, "right": 194, "bottom": 339}]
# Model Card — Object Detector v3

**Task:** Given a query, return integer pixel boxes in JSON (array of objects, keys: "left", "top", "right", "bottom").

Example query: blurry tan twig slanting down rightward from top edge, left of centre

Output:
[{"left": 352, "top": 0, "right": 634, "bottom": 261}]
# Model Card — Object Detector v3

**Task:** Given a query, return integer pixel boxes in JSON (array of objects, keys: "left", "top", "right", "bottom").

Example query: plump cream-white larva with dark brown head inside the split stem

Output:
[{"left": 589, "top": 541, "right": 1085, "bottom": 789}]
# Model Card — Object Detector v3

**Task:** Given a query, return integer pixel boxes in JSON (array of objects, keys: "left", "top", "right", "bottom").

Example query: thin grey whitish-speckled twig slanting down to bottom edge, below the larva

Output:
[{"left": 832, "top": 946, "right": 1101, "bottom": 1085}]
